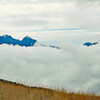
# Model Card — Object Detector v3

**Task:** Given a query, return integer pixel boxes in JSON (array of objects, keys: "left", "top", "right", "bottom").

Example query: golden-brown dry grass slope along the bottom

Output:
[{"left": 0, "top": 79, "right": 100, "bottom": 100}]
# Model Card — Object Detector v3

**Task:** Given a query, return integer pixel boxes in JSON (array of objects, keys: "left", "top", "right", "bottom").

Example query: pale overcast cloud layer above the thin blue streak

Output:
[{"left": 0, "top": 0, "right": 100, "bottom": 33}]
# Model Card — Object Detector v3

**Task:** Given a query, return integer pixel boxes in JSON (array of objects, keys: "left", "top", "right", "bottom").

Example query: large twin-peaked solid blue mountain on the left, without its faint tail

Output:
[{"left": 0, "top": 35, "right": 36, "bottom": 47}]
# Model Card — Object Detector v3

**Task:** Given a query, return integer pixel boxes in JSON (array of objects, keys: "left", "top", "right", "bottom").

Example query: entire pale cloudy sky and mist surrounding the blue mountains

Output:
[{"left": 0, "top": 0, "right": 100, "bottom": 94}]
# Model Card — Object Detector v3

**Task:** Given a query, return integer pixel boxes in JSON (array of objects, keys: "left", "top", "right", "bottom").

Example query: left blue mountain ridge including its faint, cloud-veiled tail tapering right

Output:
[{"left": 0, "top": 35, "right": 60, "bottom": 49}]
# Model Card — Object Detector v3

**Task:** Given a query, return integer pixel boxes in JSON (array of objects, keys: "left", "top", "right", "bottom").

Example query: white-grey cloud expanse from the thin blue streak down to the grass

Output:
[{"left": 0, "top": 30, "right": 100, "bottom": 94}]
